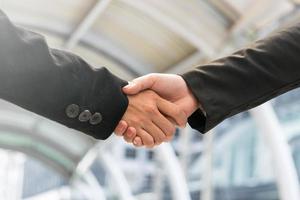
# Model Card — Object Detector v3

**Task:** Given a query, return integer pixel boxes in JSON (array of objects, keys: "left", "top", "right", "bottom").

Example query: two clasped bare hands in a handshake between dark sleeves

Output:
[{"left": 115, "top": 74, "right": 200, "bottom": 148}]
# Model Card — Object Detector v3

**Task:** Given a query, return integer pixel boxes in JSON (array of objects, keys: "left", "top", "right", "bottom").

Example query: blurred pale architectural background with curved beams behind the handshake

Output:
[{"left": 0, "top": 0, "right": 300, "bottom": 200}]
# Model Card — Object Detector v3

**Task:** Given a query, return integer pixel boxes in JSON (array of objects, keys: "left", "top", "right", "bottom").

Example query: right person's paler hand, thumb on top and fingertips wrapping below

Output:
[{"left": 116, "top": 74, "right": 199, "bottom": 146}]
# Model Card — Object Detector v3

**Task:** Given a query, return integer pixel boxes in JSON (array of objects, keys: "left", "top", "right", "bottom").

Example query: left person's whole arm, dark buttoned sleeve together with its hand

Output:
[{"left": 0, "top": 11, "right": 186, "bottom": 142}]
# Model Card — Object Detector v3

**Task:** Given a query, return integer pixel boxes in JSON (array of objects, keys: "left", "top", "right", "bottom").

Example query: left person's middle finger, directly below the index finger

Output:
[{"left": 152, "top": 113, "right": 176, "bottom": 138}]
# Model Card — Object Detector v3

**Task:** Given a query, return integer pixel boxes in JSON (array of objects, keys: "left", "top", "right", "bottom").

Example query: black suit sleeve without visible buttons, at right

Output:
[{"left": 182, "top": 23, "right": 300, "bottom": 133}]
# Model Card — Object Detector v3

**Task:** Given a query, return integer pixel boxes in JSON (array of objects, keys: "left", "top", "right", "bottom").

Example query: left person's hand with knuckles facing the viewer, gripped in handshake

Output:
[{"left": 116, "top": 90, "right": 187, "bottom": 147}]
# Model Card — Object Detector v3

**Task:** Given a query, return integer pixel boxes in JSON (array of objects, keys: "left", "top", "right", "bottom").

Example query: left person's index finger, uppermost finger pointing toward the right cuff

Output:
[{"left": 157, "top": 98, "right": 187, "bottom": 127}]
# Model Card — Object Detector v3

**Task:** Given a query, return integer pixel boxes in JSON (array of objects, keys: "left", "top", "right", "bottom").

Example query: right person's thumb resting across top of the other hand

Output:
[{"left": 123, "top": 75, "right": 154, "bottom": 95}]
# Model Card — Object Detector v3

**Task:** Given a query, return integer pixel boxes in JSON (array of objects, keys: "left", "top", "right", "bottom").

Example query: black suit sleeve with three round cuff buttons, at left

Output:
[{"left": 0, "top": 11, "right": 128, "bottom": 139}]
